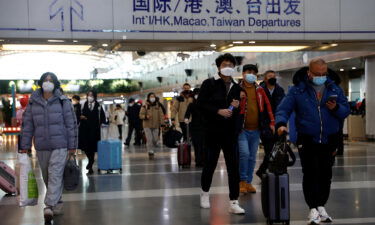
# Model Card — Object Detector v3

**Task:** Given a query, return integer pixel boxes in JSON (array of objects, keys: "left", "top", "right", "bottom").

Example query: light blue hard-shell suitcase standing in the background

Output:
[{"left": 98, "top": 139, "right": 122, "bottom": 173}]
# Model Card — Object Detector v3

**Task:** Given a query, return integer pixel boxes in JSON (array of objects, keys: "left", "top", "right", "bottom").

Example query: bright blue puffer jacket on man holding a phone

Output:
[{"left": 276, "top": 68, "right": 350, "bottom": 144}]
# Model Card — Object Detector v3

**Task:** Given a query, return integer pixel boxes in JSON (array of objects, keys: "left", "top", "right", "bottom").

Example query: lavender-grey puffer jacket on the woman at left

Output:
[{"left": 20, "top": 89, "right": 78, "bottom": 151}]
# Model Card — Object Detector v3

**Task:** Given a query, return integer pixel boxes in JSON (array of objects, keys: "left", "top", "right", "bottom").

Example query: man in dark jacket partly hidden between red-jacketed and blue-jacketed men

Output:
[{"left": 256, "top": 70, "right": 285, "bottom": 178}]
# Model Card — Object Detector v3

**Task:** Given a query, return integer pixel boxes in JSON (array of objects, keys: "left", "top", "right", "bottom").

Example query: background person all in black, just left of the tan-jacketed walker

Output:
[{"left": 125, "top": 98, "right": 141, "bottom": 145}]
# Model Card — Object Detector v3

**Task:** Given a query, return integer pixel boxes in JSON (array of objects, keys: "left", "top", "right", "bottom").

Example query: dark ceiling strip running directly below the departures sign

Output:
[{"left": 0, "top": 39, "right": 375, "bottom": 52}]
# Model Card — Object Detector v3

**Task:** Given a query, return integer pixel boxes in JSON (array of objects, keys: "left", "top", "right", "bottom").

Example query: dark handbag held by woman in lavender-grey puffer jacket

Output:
[{"left": 64, "top": 155, "right": 80, "bottom": 191}]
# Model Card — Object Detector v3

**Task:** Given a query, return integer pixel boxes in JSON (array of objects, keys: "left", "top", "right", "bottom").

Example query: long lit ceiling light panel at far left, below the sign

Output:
[{"left": 2, "top": 44, "right": 91, "bottom": 51}]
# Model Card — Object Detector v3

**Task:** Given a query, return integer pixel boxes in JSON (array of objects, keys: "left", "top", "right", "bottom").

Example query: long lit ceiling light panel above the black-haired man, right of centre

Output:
[{"left": 223, "top": 46, "right": 309, "bottom": 52}]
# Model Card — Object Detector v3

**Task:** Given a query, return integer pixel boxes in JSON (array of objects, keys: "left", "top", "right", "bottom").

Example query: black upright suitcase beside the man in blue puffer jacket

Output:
[{"left": 261, "top": 173, "right": 290, "bottom": 224}]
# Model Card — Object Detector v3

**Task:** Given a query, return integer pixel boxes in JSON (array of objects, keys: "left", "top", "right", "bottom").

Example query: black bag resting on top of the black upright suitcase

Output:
[{"left": 268, "top": 134, "right": 296, "bottom": 175}]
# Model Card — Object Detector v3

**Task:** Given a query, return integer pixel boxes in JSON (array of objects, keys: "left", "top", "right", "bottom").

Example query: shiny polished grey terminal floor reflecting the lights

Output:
[{"left": 0, "top": 134, "right": 375, "bottom": 225}]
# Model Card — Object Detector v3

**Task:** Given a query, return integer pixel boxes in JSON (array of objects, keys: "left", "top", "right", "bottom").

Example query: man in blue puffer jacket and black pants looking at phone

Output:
[{"left": 276, "top": 59, "right": 349, "bottom": 224}]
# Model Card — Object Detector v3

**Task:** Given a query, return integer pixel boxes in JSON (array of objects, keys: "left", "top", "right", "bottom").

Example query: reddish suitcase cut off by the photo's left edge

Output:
[{"left": 0, "top": 161, "right": 17, "bottom": 194}]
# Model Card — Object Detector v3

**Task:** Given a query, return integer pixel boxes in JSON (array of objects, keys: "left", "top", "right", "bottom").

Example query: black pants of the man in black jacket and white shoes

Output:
[{"left": 201, "top": 131, "right": 240, "bottom": 200}]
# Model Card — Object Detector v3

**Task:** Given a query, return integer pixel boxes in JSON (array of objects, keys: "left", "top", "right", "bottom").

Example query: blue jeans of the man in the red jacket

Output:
[{"left": 238, "top": 130, "right": 260, "bottom": 184}]
